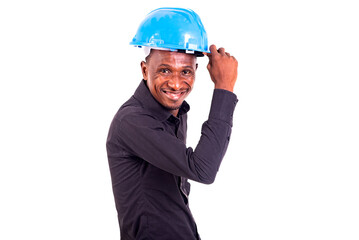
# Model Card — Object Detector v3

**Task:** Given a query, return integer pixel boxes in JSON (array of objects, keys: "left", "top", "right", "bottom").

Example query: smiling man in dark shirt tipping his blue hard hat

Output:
[{"left": 107, "top": 8, "right": 238, "bottom": 240}]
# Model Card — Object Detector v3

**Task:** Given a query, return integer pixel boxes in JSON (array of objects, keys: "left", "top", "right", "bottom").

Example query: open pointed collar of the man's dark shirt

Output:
[{"left": 134, "top": 80, "right": 190, "bottom": 121}]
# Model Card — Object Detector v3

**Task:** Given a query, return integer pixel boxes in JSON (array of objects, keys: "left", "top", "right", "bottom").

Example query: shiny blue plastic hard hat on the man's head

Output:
[{"left": 130, "top": 8, "right": 209, "bottom": 55}]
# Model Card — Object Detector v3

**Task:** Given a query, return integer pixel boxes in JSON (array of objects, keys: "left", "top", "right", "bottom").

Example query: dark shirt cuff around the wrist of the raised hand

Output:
[{"left": 209, "top": 89, "right": 238, "bottom": 126}]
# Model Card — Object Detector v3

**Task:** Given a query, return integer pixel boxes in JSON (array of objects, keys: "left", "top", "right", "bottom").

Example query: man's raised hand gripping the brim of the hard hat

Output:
[{"left": 206, "top": 45, "right": 238, "bottom": 92}]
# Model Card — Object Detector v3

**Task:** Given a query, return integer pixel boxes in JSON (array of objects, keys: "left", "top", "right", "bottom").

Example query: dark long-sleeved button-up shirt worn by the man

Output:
[{"left": 106, "top": 81, "right": 237, "bottom": 240}]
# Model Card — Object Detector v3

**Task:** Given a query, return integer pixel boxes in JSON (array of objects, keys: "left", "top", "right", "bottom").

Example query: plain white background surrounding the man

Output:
[{"left": 0, "top": 0, "right": 359, "bottom": 240}]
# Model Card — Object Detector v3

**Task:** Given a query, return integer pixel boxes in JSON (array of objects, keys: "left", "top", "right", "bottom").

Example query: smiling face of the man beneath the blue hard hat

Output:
[{"left": 141, "top": 49, "right": 197, "bottom": 116}]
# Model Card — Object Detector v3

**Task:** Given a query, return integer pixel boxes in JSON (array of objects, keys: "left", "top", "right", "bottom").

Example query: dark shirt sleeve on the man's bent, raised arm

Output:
[{"left": 114, "top": 89, "right": 238, "bottom": 184}]
